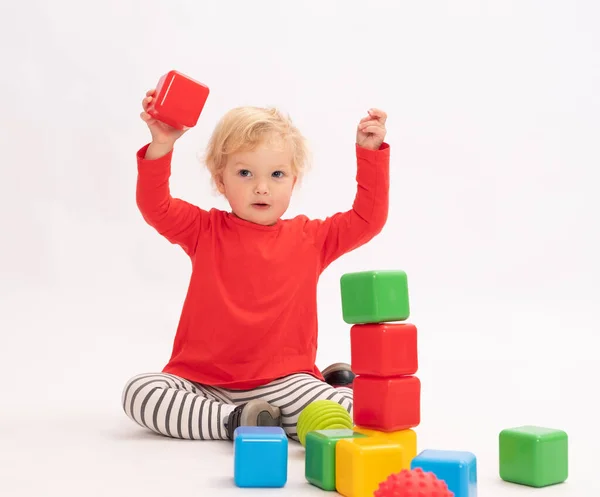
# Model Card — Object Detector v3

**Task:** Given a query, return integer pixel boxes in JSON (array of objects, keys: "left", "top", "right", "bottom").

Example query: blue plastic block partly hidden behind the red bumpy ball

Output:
[{"left": 410, "top": 450, "right": 477, "bottom": 497}]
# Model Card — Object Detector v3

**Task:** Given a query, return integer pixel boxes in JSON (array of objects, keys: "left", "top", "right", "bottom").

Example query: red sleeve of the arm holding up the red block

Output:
[{"left": 136, "top": 144, "right": 209, "bottom": 256}]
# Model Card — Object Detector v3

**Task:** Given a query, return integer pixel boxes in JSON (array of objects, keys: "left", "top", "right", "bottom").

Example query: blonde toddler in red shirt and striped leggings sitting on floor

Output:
[{"left": 122, "top": 90, "right": 390, "bottom": 440}]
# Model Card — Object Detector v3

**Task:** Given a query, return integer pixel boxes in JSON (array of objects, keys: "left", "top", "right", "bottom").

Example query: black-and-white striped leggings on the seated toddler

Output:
[{"left": 122, "top": 373, "right": 353, "bottom": 441}]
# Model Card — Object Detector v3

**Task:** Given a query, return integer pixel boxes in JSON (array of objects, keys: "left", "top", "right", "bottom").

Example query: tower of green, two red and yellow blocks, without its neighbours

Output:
[{"left": 338, "top": 270, "right": 421, "bottom": 497}]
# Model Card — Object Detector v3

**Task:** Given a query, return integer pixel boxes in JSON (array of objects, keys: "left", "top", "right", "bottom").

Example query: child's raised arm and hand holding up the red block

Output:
[{"left": 136, "top": 90, "right": 208, "bottom": 256}]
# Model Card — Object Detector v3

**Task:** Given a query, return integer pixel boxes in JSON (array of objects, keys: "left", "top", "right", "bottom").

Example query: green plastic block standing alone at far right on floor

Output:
[{"left": 499, "top": 426, "right": 569, "bottom": 488}]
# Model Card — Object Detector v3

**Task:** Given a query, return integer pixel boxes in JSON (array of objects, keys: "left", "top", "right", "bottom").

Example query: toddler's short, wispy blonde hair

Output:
[{"left": 204, "top": 106, "right": 309, "bottom": 188}]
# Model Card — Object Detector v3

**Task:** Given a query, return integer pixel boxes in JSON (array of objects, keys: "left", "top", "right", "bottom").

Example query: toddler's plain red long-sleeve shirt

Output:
[{"left": 136, "top": 143, "right": 390, "bottom": 389}]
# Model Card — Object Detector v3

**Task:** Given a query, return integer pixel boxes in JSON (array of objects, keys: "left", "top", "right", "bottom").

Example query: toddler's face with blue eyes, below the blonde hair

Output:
[{"left": 217, "top": 142, "right": 296, "bottom": 226}]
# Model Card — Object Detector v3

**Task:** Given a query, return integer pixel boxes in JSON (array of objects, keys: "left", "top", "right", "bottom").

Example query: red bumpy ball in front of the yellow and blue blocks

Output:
[{"left": 373, "top": 468, "right": 454, "bottom": 497}]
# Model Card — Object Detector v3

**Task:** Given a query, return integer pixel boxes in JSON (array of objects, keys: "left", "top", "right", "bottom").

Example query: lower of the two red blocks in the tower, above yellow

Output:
[{"left": 354, "top": 376, "right": 421, "bottom": 432}]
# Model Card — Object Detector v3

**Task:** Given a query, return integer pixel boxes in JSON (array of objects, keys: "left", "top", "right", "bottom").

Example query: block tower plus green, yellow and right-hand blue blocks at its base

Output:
[{"left": 306, "top": 270, "right": 477, "bottom": 497}]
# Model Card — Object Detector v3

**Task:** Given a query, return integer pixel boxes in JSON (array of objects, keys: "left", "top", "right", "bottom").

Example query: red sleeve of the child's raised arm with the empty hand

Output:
[{"left": 309, "top": 143, "right": 390, "bottom": 270}]
